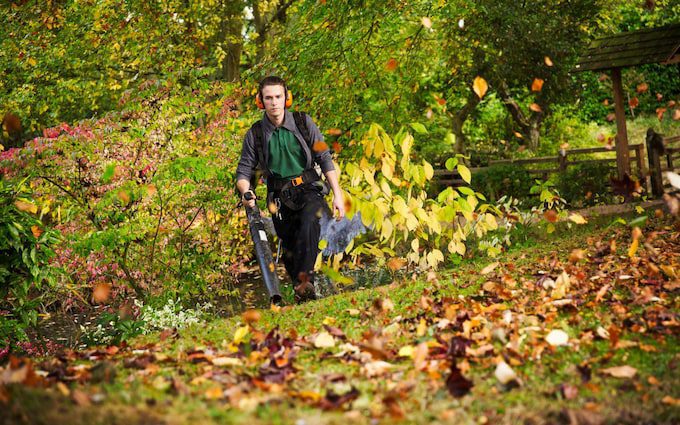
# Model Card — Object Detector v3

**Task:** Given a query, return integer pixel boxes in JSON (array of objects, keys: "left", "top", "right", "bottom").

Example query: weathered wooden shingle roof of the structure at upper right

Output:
[{"left": 574, "top": 24, "right": 680, "bottom": 71}]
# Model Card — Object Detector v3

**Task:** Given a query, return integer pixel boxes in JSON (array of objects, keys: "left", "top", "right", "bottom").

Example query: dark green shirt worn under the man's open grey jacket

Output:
[{"left": 269, "top": 127, "right": 307, "bottom": 179}]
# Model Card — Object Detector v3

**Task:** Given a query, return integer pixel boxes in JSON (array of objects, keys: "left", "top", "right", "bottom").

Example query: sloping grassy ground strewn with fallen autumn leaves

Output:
[{"left": 0, "top": 210, "right": 680, "bottom": 424}]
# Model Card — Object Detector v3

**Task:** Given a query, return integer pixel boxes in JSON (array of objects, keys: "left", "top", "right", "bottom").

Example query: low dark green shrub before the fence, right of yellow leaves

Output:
[{"left": 472, "top": 164, "right": 533, "bottom": 201}]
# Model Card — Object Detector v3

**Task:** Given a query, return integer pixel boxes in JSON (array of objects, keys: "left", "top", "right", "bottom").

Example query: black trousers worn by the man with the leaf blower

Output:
[{"left": 273, "top": 185, "right": 330, "bottom": 284}]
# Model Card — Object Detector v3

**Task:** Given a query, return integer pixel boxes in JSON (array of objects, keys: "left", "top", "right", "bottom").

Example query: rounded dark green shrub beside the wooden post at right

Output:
[{"left": 557, "top": 162, "right": 614, "bottom": 207}]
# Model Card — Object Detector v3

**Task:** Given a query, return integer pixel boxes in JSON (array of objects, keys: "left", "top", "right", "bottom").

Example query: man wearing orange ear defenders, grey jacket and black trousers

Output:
[{"left": 236, "top": 76, "right": 345, "bottom": 302}]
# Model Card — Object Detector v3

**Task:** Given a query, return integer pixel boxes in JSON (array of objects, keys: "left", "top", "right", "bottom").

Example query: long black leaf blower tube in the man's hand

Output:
[{"left": 244, "top": 192, "right": 282, "bottom": 305}]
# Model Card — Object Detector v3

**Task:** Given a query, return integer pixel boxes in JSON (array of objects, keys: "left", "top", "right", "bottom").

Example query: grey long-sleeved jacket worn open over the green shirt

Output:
[{"left": 236, "top": 109, "right": 335, "bottom": 181}]
